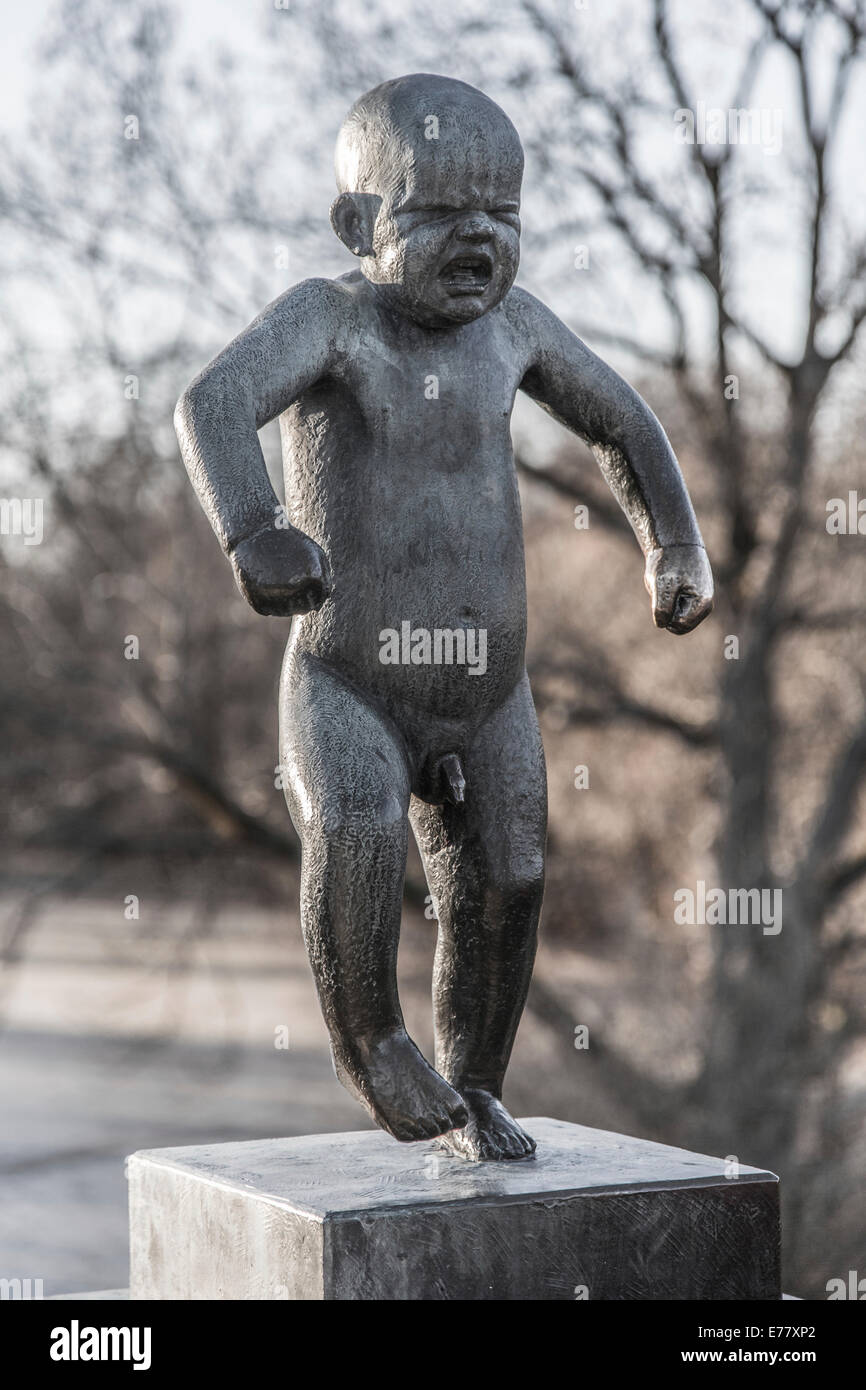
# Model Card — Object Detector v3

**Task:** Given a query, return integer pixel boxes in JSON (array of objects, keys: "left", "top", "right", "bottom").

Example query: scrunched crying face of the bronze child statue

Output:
[{"left": 364, "top": 140, "right": 523, "bottom": 327}]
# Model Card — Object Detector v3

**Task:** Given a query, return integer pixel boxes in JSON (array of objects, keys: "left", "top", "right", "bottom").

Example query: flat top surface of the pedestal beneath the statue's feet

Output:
[{"left": 132, "top": 1118, "right": 776, "bottom": 1220}]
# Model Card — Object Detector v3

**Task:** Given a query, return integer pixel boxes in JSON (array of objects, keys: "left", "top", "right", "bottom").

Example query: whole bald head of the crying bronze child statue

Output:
[{"left": 331, "top": 72, "right": 523, "bottom": 325}]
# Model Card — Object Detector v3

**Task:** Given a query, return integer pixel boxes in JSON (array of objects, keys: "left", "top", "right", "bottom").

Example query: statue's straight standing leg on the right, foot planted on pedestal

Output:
[{"left": 410, "top": 677, "right": 546, "bottom": 1159}]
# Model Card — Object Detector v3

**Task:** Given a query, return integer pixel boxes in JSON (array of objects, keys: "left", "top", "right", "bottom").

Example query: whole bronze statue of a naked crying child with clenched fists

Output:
[{"left": 175, "top": 74, "right": 713, "bottom": 1159}]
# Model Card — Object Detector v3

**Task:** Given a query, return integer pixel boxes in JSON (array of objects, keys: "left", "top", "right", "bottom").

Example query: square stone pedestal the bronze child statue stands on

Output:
[{"left": 128, "top": 1119, "right": 781, "bottom": 1300}]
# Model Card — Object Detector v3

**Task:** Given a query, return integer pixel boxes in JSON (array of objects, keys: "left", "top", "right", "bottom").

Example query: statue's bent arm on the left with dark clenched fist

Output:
[{"left": 175, "top": 279, "right": 345, "bottom": 616}]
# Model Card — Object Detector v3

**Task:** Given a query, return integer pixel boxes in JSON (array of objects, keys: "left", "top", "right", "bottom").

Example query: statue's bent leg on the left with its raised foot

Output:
[{"left": 279, "top": 653, "right": 466, "bottom": 1140}]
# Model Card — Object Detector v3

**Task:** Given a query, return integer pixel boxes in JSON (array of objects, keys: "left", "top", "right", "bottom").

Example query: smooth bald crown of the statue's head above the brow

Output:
[{"left": 335, "top": 72, "right": 523, "bottom": 196}]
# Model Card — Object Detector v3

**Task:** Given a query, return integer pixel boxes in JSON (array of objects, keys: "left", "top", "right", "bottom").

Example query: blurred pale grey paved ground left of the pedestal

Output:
[{"left": 0, "top": 1033, "right": 366, "bottom": 1294}]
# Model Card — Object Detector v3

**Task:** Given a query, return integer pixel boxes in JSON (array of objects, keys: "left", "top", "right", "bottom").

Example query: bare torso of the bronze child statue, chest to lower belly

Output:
[{"left": 281, "top": 276, "right": 525, "bottom": 721}]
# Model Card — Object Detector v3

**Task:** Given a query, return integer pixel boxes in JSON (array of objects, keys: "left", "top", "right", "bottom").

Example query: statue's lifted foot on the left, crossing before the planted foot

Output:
[{"left": 341, "top": 1029, "right": 468, "bottom": 1144}]
